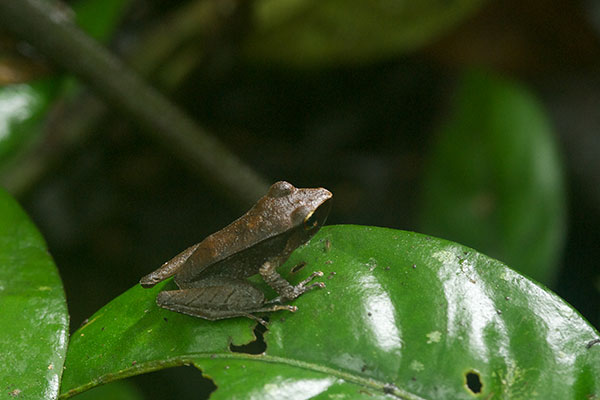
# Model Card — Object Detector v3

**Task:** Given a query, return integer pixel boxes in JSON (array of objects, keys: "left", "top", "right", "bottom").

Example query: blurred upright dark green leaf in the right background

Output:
[{"left": 420, "top": 72, "right": 566, "bottom": 284}]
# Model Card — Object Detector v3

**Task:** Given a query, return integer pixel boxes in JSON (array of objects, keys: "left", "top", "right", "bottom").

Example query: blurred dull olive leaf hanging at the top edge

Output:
[{"left": 245, "top": 0, "right": 484, "bottom": 66}]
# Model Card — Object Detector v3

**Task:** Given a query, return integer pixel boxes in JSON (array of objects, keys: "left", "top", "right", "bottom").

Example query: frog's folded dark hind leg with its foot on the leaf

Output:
[{"left": 156, "top": 278, "right": 297, "bottom": 325}]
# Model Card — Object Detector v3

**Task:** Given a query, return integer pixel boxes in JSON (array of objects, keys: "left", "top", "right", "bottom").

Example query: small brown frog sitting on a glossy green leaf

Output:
[{"left": 140, "top": 181, "right": 333, "bottom": 325}]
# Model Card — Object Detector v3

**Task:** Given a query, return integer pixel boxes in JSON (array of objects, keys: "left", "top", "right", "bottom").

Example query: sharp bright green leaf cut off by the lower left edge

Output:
[{"left": 0, "top": 189, "right": 69, "bottom": 399}]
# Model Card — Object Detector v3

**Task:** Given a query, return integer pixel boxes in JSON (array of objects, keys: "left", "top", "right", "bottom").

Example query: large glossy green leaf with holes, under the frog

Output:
[{"left": 61, "top": 226, "right": 600, "bottom": 399}]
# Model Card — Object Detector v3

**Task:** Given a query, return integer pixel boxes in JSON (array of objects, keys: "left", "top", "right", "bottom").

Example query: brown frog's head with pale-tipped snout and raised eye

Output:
[{"left": 267, "top": 181, "right": 333, "bottom": 246}]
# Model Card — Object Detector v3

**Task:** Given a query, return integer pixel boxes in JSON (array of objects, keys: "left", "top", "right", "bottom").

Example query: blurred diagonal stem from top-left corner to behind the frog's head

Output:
[{"left": 0, "top": 0, "right": 267, "bottom": 204}]
